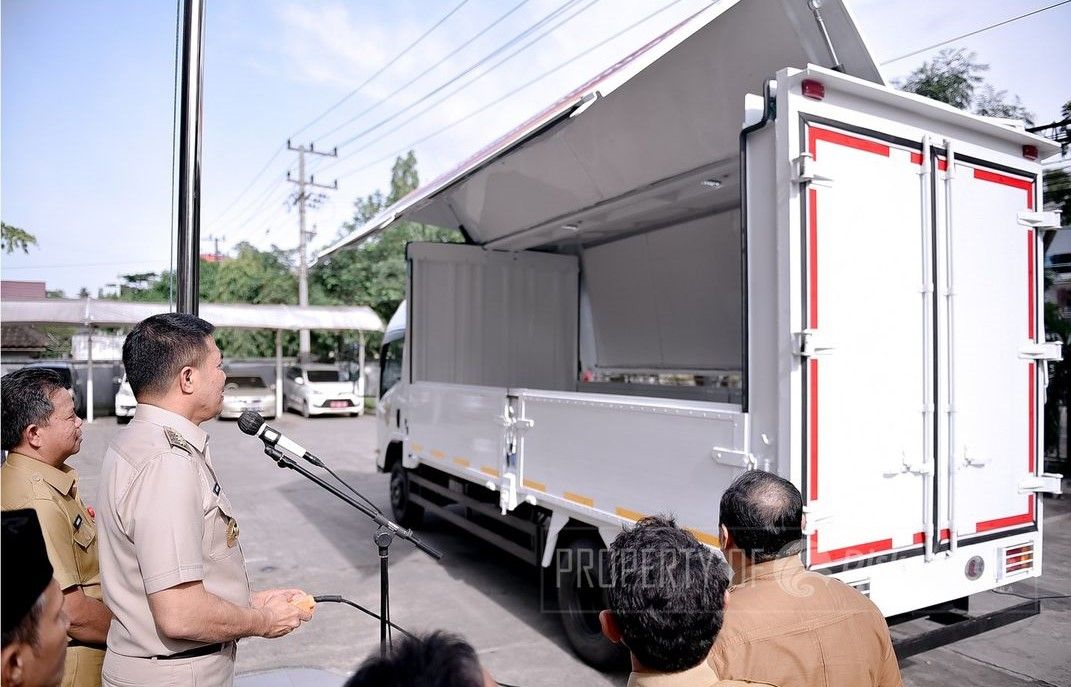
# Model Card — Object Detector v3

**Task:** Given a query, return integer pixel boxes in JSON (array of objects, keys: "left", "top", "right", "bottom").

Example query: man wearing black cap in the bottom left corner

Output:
[{"left": 0, "top": 508, "right": 70, "bottom": 687}]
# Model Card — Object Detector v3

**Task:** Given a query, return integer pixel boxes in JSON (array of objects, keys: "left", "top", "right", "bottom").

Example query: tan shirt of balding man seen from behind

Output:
[{"left": 710, "top": 556, "right": 903, "bottom": 687}]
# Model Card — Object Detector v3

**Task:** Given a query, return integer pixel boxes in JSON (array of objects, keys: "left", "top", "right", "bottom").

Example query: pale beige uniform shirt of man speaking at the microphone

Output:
[{"left": 97, "top": 403, "right": 250, "bottom": 662}]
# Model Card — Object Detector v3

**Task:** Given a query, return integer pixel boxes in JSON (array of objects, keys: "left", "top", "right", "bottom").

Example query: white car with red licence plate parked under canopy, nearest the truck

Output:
[{"left": 283, "top": 363, "right": 364, "bottom": 417}]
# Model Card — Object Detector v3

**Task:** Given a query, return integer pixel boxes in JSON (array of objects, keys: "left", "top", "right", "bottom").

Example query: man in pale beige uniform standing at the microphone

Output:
[{"left": 100, "top": 313, "right": 312, "bottom": 687}]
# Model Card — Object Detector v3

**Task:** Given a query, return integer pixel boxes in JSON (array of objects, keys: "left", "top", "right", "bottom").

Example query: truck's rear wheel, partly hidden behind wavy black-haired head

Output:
[{"left": 555, "top": 537, "right": 629, "bottom": 671}]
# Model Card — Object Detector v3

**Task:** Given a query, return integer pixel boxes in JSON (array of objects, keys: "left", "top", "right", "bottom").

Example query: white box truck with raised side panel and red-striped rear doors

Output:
[{"left": 317, "top": 0, "right": 1060, "bottom": 664}]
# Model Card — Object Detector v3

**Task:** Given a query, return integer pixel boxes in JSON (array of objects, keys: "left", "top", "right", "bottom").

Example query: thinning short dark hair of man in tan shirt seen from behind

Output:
[{"left": 719, "top": 469, "right": 803, "bottom": 563}]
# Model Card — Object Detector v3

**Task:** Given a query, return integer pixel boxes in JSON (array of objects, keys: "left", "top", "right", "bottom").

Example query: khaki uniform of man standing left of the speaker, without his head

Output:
[{"left": 0, "top": 453, "right": 104, "bottom": 687}]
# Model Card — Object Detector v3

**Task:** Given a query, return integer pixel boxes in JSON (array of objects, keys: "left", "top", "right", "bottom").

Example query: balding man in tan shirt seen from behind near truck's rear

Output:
[{"left": 710, "top": 471, "right": 903, "bottom": 687}]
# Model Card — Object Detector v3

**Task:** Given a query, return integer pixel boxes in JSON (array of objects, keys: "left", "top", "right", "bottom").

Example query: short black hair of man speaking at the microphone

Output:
[{"left": 123, "top": 313, "right": 215, "bottom": 401}]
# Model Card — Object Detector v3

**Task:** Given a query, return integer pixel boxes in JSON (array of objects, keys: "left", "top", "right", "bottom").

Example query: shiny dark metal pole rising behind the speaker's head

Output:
[{"left": 176, "top": 0, "right": 205, "bottom": 315}]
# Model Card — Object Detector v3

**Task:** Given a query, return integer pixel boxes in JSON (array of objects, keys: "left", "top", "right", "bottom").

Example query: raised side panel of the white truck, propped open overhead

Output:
[{"left": 320, "top": 0, "right": 884, "bottom": 257}]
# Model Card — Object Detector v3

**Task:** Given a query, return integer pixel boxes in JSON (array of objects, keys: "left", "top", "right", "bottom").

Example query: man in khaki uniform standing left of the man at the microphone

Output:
[{"left": 0, "top": 368, "right": 111, "bottom": 687}]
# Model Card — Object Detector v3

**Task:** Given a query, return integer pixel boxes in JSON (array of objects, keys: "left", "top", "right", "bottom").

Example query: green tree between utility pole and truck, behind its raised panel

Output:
[{"left": 310, "top": 151, "right": 462, "bottom": 352}]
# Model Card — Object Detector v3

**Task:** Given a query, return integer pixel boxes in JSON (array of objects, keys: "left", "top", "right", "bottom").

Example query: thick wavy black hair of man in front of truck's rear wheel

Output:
[{"left": 608, "top": 517, "right": 729, "bottom": 673}]
